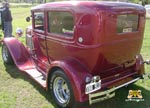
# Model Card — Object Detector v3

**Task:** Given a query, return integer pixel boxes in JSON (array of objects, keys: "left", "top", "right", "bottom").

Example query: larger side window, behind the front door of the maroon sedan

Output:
[{"left": 48, "top": 12, "right": 74, "bottom": 37}]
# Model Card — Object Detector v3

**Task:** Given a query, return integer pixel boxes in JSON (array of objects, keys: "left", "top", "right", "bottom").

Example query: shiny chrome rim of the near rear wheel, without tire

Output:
[{"left": 53, "top": 77, "right": 70, "bottom": 104}]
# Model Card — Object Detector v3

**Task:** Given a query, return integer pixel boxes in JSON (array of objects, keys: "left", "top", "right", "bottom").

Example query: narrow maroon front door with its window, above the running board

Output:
[{"left": 32, "top": 11, "right": 49, "bottom": 72}]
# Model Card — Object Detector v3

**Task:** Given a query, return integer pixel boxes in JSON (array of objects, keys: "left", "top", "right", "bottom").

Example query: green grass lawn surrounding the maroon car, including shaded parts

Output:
[{"left": 0, "top": 7, "right": 150, "bottom": 108}]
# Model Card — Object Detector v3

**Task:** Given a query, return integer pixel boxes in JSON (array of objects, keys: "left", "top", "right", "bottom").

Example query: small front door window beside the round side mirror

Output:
[{"left": 34, "top": 12, "right": 44, "bottom": 31}]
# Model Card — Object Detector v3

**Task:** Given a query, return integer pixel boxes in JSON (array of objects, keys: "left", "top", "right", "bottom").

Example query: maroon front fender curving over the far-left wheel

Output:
[{"left": 3, "top": 37, "right": 33, "bottom": 70}]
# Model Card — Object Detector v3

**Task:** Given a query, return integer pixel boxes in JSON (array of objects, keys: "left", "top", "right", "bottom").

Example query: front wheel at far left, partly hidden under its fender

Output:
[{"left": 2, "top": 44, "right": 13, "bottom": 64}]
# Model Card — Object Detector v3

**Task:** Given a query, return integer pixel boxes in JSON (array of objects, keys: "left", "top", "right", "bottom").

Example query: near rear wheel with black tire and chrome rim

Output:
[{"left": 49, "top": 70, "right": 75, "bottom": 108}]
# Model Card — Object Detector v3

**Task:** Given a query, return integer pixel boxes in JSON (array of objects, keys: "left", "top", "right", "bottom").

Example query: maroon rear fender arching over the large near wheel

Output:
[{"left": 47, "top": 58, "right": 92, "bottom": 102}]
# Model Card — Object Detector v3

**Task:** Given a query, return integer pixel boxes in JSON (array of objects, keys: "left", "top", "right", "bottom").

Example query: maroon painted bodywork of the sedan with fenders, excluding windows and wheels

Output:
[{"left": 4, "top": 1, "right": 145, "bottom": 102}]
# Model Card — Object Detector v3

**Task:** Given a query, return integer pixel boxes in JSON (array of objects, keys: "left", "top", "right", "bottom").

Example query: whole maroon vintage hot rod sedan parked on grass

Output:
[{"left": 2, "top": 1, "right": 148, "bottom": 108}]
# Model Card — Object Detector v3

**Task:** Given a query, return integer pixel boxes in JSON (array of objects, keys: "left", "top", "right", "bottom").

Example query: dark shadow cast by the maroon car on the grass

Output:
[{"left": 5, "top": 65, "right": 150, "bottom": 108}]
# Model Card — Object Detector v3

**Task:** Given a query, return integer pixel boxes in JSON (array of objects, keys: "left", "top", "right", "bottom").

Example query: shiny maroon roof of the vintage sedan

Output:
[{"left": 32, "top": 1, "right": 142, "bottom": 10}]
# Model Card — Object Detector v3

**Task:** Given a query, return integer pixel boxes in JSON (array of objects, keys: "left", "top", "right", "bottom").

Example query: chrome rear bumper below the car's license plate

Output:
[{"left": 89, "top": 77, "right": 141, "bottom": 105}]
